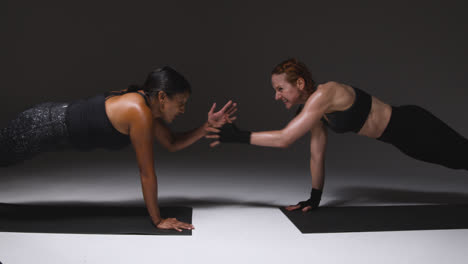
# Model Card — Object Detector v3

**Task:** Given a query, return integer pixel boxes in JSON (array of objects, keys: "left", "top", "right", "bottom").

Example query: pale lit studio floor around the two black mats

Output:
[{"left": 0, "top": 152, "right": 468, "bottom": 264}]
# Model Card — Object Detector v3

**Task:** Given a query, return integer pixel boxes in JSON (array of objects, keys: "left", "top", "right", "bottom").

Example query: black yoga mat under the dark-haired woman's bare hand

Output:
[{"left": 0, "top": 204, "right": 192, "bottom": 236}]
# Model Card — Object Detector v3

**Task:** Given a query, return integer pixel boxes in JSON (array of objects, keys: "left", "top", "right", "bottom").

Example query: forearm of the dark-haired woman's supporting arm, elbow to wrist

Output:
[{"left": 141, "top": 174, "right": 161, "bottom": 225}]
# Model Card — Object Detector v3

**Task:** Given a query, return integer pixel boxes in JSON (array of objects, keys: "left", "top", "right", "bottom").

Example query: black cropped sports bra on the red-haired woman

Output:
[{"left": 296, "top": 87, "right": 372, "bottom": 133}]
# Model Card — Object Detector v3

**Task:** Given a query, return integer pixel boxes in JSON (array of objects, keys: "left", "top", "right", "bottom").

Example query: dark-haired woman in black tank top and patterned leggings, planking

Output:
[{"left": 0, "top": 67, "right": 236, "bottom": 231}]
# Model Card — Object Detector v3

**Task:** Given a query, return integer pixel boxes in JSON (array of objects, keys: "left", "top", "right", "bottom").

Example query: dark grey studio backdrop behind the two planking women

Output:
[{"left": 0, "top": 1, "right": 468, "bottom": 177}]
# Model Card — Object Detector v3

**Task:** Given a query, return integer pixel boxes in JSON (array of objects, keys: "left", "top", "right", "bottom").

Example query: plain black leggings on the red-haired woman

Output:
[{"left": 378, "top": 105, "right": 468, "bottom": 170}]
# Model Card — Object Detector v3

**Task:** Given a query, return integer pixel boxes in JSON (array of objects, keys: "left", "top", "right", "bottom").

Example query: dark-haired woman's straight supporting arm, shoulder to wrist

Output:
[{"left": 129, "top": 106, "right": 161, "bottom": 225}]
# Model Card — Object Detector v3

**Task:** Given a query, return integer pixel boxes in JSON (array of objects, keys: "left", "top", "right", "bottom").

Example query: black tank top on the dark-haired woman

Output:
[{"left": 65, "top": 91, "right": 149, "bottom": 151}]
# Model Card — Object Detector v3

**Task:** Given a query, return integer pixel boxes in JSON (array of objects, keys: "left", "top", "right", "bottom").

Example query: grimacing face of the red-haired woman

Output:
[{"left": 271, "top": 73, "right": 302, "bottom": 109}]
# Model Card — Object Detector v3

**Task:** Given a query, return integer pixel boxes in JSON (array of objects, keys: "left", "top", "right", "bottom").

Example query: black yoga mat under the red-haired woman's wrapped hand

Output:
[{"left": 280, "top": 205, "right": 468, "bottom": 234}]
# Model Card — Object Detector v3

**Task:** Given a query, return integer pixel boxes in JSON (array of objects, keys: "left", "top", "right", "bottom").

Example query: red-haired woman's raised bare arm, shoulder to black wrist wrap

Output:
[{"left": 250, "top": 91, "right": 330, "bottom": 148}]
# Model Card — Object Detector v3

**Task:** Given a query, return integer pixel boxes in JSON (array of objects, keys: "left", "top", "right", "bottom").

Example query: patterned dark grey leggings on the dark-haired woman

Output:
[{"left": 0, "top": 102, "right": 69, "bottom": 166}]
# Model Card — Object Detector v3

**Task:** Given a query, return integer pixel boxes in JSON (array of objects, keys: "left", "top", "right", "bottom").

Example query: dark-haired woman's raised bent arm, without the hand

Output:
[{"left": 153, "top": 118, "right": 208, "bottom": 152}]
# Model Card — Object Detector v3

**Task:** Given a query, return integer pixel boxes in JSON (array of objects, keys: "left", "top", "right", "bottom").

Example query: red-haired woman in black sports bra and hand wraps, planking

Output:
[{"left": 206, "top": 59, "right": 468, "bottom": 212}]
